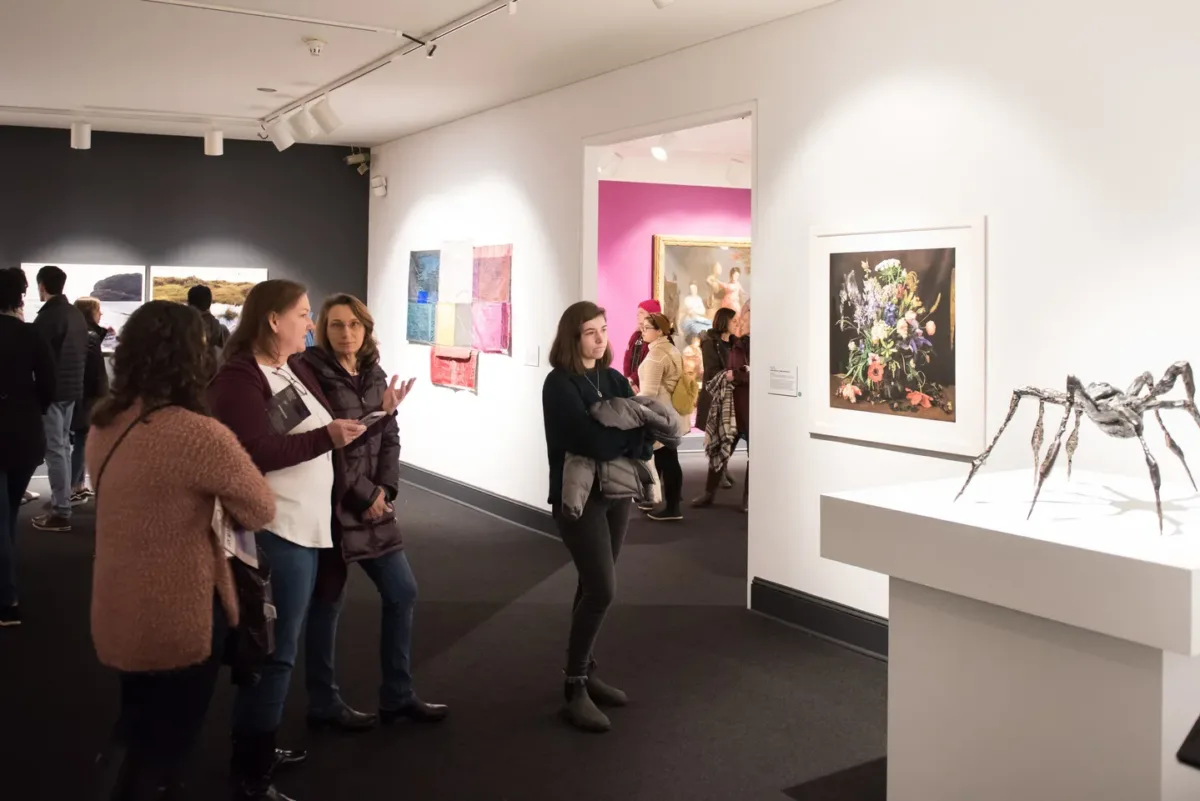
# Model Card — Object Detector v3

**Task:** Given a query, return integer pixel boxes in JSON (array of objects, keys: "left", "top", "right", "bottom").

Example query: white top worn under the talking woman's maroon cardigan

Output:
[{"left": 258, "top": 365, "right": 334, "bottom": 548}]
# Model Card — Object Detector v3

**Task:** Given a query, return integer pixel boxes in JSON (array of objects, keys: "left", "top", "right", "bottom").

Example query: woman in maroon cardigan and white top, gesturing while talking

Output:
[{"left": 209, "top": 281, "right": 398, "bottom": 801}]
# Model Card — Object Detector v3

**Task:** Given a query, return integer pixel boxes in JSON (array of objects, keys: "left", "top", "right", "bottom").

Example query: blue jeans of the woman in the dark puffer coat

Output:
[{"left": 305, "top": 550, "right": 416, "bottom": 717}]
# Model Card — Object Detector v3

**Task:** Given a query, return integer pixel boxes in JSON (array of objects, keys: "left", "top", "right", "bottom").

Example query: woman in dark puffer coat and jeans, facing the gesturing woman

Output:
[{"left": 305, "top": 294, "right": 448, "bottom": 729}]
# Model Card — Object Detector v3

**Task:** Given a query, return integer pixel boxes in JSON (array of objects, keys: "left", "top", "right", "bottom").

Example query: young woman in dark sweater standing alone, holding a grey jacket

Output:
[{"left": 541, "top": 301, "right": 650, "bottom": 731}]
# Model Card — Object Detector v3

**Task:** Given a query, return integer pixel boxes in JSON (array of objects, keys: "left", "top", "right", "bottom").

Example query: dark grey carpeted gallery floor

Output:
[{"left": 0, "top": 454, "right": 887, "bottom": 801}]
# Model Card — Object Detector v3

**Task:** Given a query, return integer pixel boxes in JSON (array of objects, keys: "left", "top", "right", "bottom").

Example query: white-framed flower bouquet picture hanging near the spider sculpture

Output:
[{"left": 810, "top": 218, "right": 986, "bottom": 456}]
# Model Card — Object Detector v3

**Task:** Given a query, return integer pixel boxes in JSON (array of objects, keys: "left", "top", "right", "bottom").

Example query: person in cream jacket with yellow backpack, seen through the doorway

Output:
[{"left": 637, "top": 314, "right": 691, "bottom": 520}]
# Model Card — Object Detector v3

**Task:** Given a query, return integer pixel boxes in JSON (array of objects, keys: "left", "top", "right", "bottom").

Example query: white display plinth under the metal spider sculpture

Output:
[{"left": 821, "top": 464, "right": 1200, "bottom": 801}]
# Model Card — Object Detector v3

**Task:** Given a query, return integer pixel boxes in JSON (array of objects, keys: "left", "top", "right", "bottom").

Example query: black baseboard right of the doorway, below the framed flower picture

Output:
[{"left": 750, "top": 577, "right": 888, "bottom": 658}]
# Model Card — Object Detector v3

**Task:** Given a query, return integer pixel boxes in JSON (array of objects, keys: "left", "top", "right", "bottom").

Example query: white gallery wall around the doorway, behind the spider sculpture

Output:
[{"left": 370, "top": 0, "right": 1200, "bottom": 615}]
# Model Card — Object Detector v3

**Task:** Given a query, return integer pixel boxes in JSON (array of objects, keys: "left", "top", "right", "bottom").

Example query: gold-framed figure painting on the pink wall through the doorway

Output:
[{"left": 653, "top": 234, "right": 752, "bottom": 344}]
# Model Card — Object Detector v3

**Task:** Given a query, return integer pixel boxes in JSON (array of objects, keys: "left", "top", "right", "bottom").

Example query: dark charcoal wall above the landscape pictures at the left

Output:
[{"left": 0, "top": 126, "right": 370, "bottom": 307}]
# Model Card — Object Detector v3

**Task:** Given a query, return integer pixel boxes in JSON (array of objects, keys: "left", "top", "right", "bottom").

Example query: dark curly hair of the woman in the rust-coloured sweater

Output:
[{"left": 91, "top": 301, "right": 216, "bottom": 427}]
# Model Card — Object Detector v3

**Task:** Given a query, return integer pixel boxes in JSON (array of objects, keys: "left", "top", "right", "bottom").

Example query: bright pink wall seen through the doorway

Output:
[{"left": 596, "top": 181, "right": 750, "bottom": 369}]
